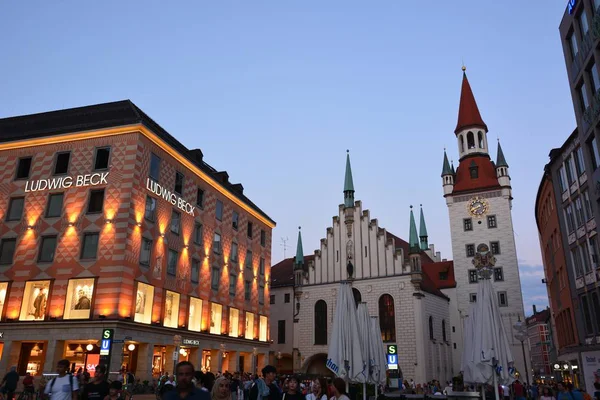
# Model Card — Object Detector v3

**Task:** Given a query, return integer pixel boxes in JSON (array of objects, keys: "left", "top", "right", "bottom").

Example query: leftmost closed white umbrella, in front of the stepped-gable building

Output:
[{"left": 326, "top": 282, "right": 364, "bottom": 382}]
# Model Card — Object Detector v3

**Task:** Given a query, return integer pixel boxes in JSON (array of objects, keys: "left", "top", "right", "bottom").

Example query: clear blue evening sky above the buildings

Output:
[{"left": 0, "top": 0, "right": 575, "bottom": 314}]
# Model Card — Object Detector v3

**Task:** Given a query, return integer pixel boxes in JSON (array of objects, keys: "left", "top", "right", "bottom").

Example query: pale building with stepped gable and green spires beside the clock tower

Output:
[{"left": 272, "top": 152, "right": 458, "bottom": 382}]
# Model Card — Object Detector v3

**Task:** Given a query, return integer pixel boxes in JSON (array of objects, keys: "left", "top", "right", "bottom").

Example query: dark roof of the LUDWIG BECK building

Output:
[{"left": 0, "top": 100, "right": 275, "bottom": 225}]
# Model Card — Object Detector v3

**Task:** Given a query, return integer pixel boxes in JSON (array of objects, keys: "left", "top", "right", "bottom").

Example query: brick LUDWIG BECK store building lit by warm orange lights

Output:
[{"left": 0, "top": 101, "right": 275, "bottom": 380}]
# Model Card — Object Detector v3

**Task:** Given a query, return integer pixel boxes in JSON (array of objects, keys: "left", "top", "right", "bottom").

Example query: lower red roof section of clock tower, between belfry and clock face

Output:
[{"left": 452, "top": 154, "right": 500, "bottom": 194}]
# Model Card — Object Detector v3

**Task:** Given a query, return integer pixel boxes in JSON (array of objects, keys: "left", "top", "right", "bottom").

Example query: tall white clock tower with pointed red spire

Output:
[{"left": 442, "top": 67, "right": 526, "bottom": 380}]
